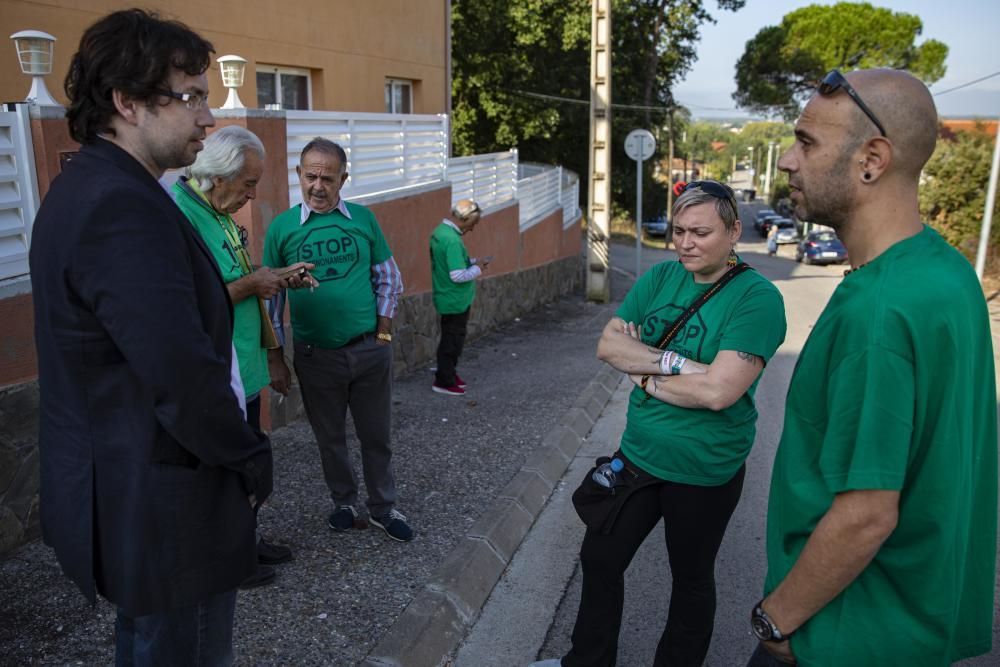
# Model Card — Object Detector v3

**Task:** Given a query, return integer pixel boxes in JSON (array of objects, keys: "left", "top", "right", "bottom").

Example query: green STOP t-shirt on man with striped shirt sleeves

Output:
[{"left": 264, "top": 202, "right": 392, "bottom": 348}]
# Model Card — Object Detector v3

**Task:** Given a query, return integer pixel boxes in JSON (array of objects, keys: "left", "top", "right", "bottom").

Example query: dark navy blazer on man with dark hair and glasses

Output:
[{"left": 30, "top": 139, "right": 271, "bottom": 616}]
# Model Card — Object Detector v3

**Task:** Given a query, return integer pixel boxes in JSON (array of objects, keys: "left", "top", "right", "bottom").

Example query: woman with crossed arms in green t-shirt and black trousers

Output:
[{"left": 534, "top": 181, "right": 785, "bottom": 667}]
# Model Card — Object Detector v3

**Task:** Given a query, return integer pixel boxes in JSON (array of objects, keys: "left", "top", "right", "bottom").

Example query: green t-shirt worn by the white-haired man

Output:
[{"left": 171, "top": 180, "right": 271, "bottom": 397}]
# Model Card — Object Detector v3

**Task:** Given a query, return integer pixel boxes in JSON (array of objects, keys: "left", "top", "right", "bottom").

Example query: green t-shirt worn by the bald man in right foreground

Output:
[{"left": 766, "top": 227, "right": 997, "bottom": 667}]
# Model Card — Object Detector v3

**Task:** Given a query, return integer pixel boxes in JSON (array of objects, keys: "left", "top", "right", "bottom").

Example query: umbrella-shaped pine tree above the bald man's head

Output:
[{"left": 733, "top": 2, "right": 948, "bottom": 118}]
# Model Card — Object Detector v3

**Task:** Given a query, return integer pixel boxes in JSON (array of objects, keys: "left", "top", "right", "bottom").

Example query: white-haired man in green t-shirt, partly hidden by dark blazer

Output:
[{"left": 171, "top": 126, "right": 312, "bottom": 588}]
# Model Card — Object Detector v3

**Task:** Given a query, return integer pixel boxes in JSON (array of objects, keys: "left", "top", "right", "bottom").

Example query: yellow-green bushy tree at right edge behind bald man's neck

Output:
[{"left": 920, "top": 126, "right": 1000, "bottom": 273}]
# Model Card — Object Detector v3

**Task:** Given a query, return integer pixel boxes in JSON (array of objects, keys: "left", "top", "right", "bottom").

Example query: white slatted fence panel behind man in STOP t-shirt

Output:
[{"left": 285, "top": 111, "right": 448, "bottom": 206}]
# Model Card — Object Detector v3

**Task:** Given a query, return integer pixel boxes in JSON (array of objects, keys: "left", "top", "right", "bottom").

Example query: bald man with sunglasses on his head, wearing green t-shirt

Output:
[{"left": 749, "top": 70, "right": 997, "bottom": 667}]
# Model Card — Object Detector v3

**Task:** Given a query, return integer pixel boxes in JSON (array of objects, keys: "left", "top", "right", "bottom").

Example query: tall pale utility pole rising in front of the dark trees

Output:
[{"left": 587, "top": 0, "right": 611, "bottom": 303}]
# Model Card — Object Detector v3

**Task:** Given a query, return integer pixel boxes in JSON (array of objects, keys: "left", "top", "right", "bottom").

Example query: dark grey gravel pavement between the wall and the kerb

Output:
[{"left": 0, "top": 275, "right": 629, "bottom": 665}]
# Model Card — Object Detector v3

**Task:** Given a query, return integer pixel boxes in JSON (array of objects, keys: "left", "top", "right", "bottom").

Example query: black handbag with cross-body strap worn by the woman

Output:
[{"left": 573, "top": 263, "right": 753, "bottom": 535}]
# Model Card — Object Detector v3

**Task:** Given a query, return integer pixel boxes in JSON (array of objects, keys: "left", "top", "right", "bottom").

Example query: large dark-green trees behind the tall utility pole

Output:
[{"left": 452, "top": 0, "right": 746, "bottom": 219}]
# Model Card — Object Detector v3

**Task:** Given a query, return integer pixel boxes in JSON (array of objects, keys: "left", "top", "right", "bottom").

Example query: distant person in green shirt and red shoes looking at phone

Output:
[{"left": 431, "top": 199, "right": 492, "bottom": 396}]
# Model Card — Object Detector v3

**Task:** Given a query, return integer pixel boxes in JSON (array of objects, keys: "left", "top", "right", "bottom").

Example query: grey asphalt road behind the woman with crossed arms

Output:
[{"left": 454, "top": 204, "right": 1000, "bottom": 667}]
